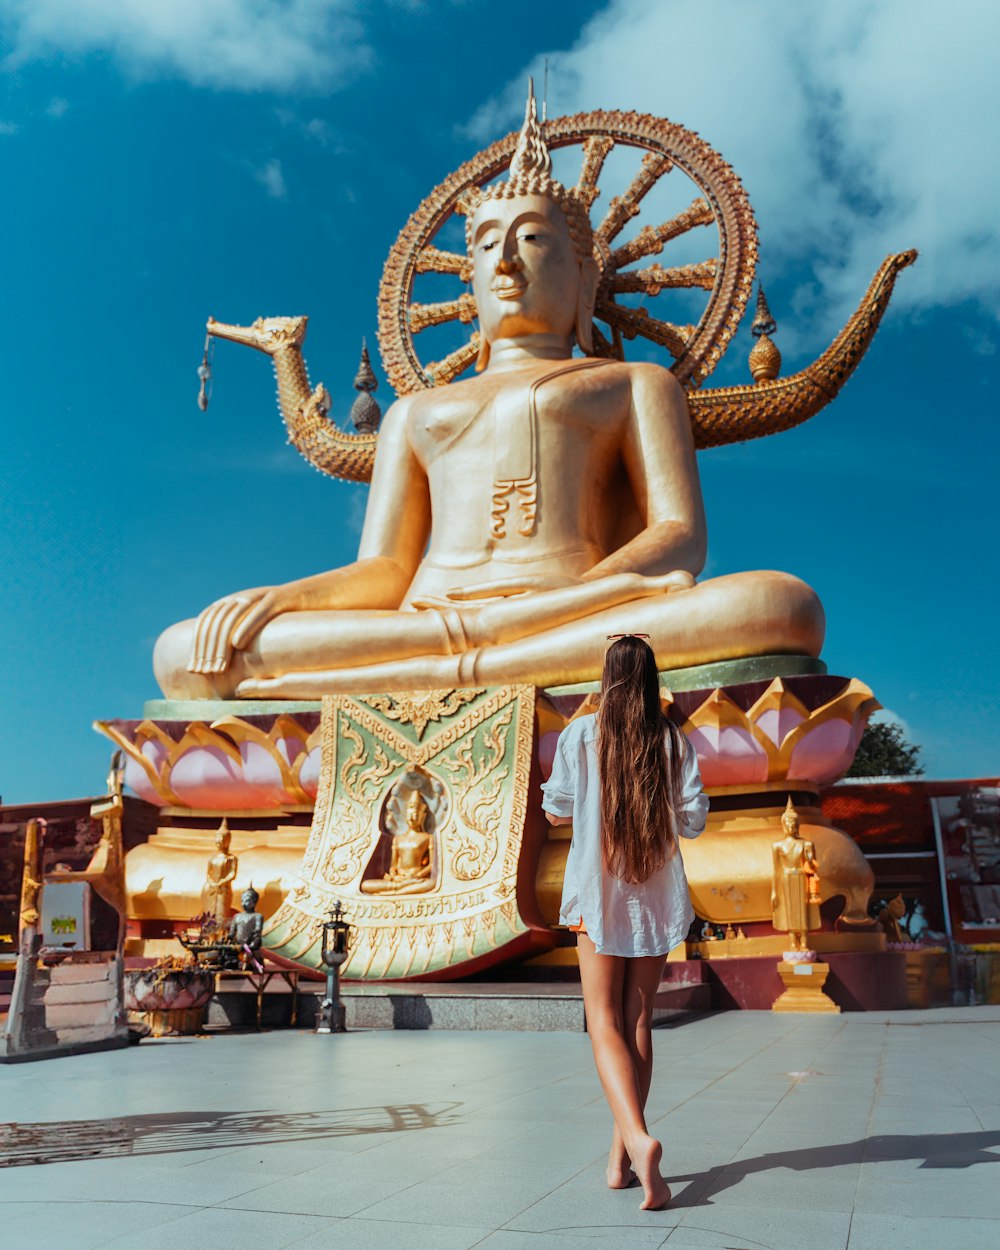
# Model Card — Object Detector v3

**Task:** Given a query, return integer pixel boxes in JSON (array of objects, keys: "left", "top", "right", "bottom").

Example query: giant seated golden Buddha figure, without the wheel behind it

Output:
[{"left": 154, "top": 98, "right": 860, "bottom": 699}]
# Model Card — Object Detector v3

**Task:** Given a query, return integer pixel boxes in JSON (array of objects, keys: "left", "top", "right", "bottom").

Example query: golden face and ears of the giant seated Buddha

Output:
[{"left": 470, "top": 194, "right": 599, "bottom": 350}]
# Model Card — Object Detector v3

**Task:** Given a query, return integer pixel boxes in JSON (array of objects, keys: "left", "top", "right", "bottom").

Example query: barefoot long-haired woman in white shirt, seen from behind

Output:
[{"left": 543, "top": 634, "right": 709, "bottom": 1210}]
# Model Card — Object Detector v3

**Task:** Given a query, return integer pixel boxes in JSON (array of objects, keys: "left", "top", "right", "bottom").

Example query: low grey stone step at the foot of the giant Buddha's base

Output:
[{"left": 205, "top": 979, "right": 711, "bottom": 1033}]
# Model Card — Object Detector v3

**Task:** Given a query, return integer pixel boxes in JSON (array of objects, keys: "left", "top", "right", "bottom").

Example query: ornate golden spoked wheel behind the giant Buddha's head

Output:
[{"left": 379, "top": 113, "right": 758, "bottom": 395}]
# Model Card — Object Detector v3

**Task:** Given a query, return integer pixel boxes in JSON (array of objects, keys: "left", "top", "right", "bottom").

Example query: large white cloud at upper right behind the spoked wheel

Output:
[{"left": 469, "top": 0, "right": 1000, "bottom": 343}]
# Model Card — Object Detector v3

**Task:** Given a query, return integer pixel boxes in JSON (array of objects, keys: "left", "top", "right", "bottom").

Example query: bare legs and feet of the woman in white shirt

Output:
[{"left": 578, "top": 934, "right": 670, "bottom": 1210}]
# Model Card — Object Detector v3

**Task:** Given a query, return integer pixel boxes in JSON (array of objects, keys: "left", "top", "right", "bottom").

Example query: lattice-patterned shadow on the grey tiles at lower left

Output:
[{"left": 0, "top": 1103, "right": 461, "bottom": 1168}]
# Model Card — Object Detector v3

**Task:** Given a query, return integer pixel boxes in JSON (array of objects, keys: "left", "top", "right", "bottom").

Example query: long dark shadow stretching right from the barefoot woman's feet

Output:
[{"left": 668, "top": 1130, "right": 1000, "bottom": 1208}]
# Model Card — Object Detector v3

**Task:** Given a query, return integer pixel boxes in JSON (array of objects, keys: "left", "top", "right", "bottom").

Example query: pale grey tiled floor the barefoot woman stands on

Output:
[{"left": 0, "top": 1008, "right": 1000, "bottom": 1250}]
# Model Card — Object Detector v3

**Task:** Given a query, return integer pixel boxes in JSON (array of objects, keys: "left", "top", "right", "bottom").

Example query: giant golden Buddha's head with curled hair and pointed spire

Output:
[{"left": 465, "top": 91, "right": 600, "bottom": 370}]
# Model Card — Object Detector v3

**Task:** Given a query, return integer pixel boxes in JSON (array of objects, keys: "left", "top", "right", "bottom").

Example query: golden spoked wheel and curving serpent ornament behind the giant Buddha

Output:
[{"left": 208, "top": 111, "right": 916, "bottom": 481}]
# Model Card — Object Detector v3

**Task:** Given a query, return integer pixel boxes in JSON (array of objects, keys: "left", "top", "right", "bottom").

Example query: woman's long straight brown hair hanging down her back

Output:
[{"left": 598, "top": 634, "right": 685, "bottom": 883}]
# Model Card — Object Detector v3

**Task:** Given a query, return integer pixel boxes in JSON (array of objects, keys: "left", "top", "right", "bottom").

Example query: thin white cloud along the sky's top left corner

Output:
[{"left": 4, "top": 0, "right": 369, "bottom": 93}]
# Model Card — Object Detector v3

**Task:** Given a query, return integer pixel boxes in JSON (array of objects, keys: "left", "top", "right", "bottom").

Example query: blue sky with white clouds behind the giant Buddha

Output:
[{"left": 0, "top": 0, "right": 1000, "bottom": 803}]
